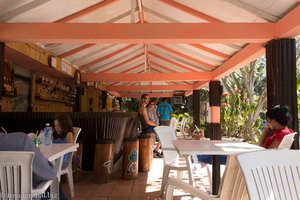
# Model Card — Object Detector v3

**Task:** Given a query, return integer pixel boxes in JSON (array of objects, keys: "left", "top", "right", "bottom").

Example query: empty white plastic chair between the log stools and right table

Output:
[{"left": 154, "top": 126, "right": 188, "bottom": 194}]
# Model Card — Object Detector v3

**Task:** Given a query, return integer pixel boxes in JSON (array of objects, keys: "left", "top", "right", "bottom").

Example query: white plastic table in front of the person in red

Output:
[{"left": 172, "top": 140, "right": 264, "bottom": 195}]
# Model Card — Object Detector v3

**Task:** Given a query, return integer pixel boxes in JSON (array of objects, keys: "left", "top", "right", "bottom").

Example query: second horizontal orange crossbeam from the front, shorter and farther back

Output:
[{"left": 81, "top": 72, "right": 212, "bottom": 82}]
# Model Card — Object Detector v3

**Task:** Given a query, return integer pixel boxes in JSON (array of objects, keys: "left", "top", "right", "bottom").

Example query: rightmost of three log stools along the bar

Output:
[{"left": 138, "top": 134, "right": 152, "bottom": 172}]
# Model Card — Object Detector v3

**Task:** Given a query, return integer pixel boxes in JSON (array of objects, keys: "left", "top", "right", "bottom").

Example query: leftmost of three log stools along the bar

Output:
[{"left": 93, "top": 140, "right": 114, "bottom": 183}]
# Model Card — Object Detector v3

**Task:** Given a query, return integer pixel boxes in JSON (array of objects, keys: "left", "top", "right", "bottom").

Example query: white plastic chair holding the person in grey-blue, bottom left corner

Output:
[{"left": 0, "top": 151, "right": 53, "bottom": 199}]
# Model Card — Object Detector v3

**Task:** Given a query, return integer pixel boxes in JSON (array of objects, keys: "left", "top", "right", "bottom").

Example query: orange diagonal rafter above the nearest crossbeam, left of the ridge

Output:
[{"left": 55, "top": 0, "right": 117, "bottom": 23}]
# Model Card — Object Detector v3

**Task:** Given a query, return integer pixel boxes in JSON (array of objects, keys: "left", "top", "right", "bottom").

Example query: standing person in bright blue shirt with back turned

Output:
[{"left": 157, "top": 98, "right": 173, "bottom": 126}]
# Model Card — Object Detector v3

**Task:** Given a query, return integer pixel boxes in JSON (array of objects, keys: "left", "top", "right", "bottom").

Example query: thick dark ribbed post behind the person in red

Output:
[{"left": 266, "top": 38, "right": 299, "bottom": 149}]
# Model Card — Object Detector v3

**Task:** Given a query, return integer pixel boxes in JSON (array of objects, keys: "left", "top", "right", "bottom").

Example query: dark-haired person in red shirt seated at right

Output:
[{"left": 258, "top": 105, "right": 294, "bottom": 149}]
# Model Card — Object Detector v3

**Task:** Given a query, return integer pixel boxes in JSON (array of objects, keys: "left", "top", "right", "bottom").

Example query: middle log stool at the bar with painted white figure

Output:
[{"left": 122, "top": 137, "right": 139, "bottom": 179}]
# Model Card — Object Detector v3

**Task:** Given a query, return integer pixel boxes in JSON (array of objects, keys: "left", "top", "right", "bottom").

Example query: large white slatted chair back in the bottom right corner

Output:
[{"left": 237, "top": 149, "right": 300, "bottom": 200}]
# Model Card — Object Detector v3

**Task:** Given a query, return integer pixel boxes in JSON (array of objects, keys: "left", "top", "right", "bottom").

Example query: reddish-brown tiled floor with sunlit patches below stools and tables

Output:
[{"left": 63, "top": 158, "right": 209, "bottom": 200}]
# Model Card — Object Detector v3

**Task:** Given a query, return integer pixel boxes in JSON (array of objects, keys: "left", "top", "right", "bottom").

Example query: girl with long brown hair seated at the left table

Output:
[{"left": 53, "top": 114, "right": 74, "bottom": 169}]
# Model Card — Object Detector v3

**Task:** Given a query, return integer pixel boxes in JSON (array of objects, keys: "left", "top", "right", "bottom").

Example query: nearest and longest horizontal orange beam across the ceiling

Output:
[{"left": 0, "top": 22, "right": 274, "bottom": 44}]
